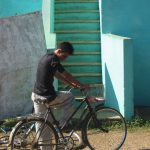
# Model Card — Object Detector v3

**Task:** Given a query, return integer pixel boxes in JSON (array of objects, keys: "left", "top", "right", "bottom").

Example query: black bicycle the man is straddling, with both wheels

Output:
[{"left": 9, "top": 87, "right": 127, "bottom": 150}]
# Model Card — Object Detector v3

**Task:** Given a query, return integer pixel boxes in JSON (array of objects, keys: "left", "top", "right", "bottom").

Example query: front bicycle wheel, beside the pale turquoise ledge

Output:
[{"left": 82, "top": 106, "right": 127, "bottom": 150}]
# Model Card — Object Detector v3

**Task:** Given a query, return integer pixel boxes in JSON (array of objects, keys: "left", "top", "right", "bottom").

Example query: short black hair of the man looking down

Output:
[{"left": 58, "top": 42, "right": 74, "bottom": 55}]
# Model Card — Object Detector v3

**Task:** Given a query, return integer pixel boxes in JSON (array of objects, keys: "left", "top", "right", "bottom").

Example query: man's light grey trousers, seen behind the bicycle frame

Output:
[{"left": 32, "top": 91, "right": 75, "bottom": 150}]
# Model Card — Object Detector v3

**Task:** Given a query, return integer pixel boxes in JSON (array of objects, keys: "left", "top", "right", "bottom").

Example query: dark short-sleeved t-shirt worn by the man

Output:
[{"left": 34, "top": 53, "right": 65, "bottom": 98}]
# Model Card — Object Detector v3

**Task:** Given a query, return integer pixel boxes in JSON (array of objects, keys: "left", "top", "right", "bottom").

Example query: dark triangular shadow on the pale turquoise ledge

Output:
[{"left": 104, "top": 64, "right": 119, "bottom": 110}]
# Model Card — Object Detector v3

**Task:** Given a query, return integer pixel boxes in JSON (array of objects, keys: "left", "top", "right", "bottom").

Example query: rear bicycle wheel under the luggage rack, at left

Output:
[{"left": 9, "top": 117, "right": 58, "bottom": 150}]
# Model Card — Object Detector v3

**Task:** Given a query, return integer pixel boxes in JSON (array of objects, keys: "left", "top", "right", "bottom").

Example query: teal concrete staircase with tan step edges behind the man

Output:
[{"left": 55, "top": 0, "right": 102, "bottom": 96}]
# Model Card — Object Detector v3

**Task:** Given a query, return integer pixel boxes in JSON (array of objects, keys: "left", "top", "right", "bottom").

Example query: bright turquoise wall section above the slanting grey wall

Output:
[{"left": 0, "top": 0, "right": 42, "bottom": 18}]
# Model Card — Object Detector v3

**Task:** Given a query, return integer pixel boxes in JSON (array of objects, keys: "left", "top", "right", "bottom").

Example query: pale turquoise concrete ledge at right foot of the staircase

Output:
[{"left": 101, "top": 33, "right": 134, "bottom": 118}]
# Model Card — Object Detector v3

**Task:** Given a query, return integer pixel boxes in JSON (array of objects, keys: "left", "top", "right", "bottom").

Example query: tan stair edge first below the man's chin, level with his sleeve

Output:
[{"left": 62, "top": 62, "right": 101, "bottom": 66}]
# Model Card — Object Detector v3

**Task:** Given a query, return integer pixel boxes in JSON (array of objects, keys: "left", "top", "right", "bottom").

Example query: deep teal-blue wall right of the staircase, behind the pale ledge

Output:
[{"left": 99, "top": 0, "right": 150, "bottom": 106}]
